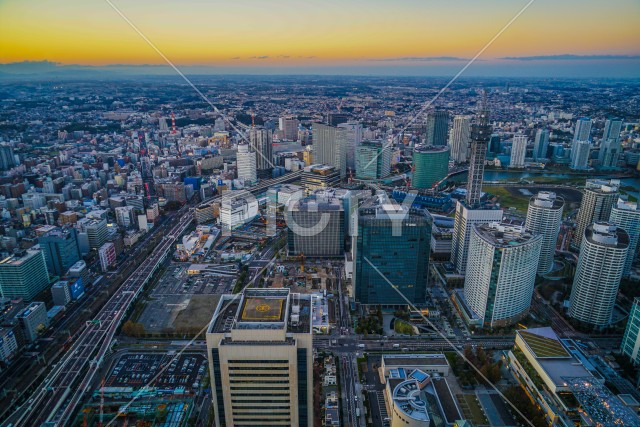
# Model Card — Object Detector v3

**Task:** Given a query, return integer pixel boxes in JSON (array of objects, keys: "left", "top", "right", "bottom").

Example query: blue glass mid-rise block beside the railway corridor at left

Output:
[{"left": 38, "top": 227, "right": 80, "bottom": 277}]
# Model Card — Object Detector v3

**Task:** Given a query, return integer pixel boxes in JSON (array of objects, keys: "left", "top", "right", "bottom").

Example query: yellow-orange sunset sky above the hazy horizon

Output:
[{"left": 0, "top": 0, "right": 640, "bottom": 73}]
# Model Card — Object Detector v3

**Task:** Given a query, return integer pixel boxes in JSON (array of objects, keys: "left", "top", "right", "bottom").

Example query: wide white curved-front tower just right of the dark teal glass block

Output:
[{"left": 464, "top": 223, "right": 542, "bottom": 327}]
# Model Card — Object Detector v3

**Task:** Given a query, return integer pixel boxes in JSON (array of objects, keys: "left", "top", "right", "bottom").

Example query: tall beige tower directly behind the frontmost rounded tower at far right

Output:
[{"left": 571, "top": 179, "right": 620, "bottom": 249}]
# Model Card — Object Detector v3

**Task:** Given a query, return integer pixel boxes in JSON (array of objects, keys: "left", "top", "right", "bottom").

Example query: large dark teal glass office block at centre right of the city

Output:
[{"left": 352, "top": 193, "right": 433, "bottom": 306}]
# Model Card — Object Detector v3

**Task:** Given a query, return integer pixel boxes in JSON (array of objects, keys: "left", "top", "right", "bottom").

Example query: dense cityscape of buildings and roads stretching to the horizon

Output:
[{"left": 0, "top": 76, "right": 640, "bottom": 427}]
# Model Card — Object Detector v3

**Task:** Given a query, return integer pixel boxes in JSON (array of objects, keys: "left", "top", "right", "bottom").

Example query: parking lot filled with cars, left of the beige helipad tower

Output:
[{"left": 105, "top": 353, "right": 207, "bottom": 390}]
